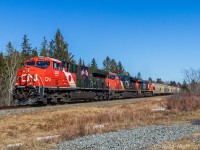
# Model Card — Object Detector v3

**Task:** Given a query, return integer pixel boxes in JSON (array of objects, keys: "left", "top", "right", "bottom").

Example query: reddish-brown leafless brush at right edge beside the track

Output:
[{"left": 166, "top": 94, "right": 200, "bottom": 111}]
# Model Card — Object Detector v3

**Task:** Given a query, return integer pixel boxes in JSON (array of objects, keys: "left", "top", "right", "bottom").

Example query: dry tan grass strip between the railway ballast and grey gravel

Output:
[{"left": 0, "top": 96, "right": 200, "bottom": 149}]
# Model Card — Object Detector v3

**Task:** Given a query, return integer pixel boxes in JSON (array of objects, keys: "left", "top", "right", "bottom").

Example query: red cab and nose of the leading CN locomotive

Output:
[{"left": 17, "top": 57, "right": 76, "bottom": 88}]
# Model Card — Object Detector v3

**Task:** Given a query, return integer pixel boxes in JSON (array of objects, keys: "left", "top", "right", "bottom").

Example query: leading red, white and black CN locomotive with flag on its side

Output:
[{"left": 14, "top": 56, "right": 109, "bottom": 105}]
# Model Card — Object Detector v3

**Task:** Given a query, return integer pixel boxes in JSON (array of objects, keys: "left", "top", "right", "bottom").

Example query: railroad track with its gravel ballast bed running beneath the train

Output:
[{"left": 0, "top": 95, "right": 170, "bottom": 116}]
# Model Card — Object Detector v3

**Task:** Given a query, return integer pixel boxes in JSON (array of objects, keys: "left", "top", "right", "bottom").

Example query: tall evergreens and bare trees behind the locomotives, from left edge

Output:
[{"left": 0, "top": 29, "right": 129, "bottom": 105}]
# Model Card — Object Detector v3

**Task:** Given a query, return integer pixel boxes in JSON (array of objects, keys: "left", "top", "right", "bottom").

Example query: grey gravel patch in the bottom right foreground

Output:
[{"left": 57, "top": 123, "right": 200, "bottom": 150}]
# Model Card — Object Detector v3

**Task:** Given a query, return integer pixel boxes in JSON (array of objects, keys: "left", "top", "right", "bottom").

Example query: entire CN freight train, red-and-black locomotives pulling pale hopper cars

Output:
[{"left": 13, "top": 56, "right": 179, "bottom": 105}]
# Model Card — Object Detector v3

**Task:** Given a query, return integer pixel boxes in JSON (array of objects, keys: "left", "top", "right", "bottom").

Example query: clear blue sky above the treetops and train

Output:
[{"left": 0, "top": 0, "right": 200, "bottom": 82}]
